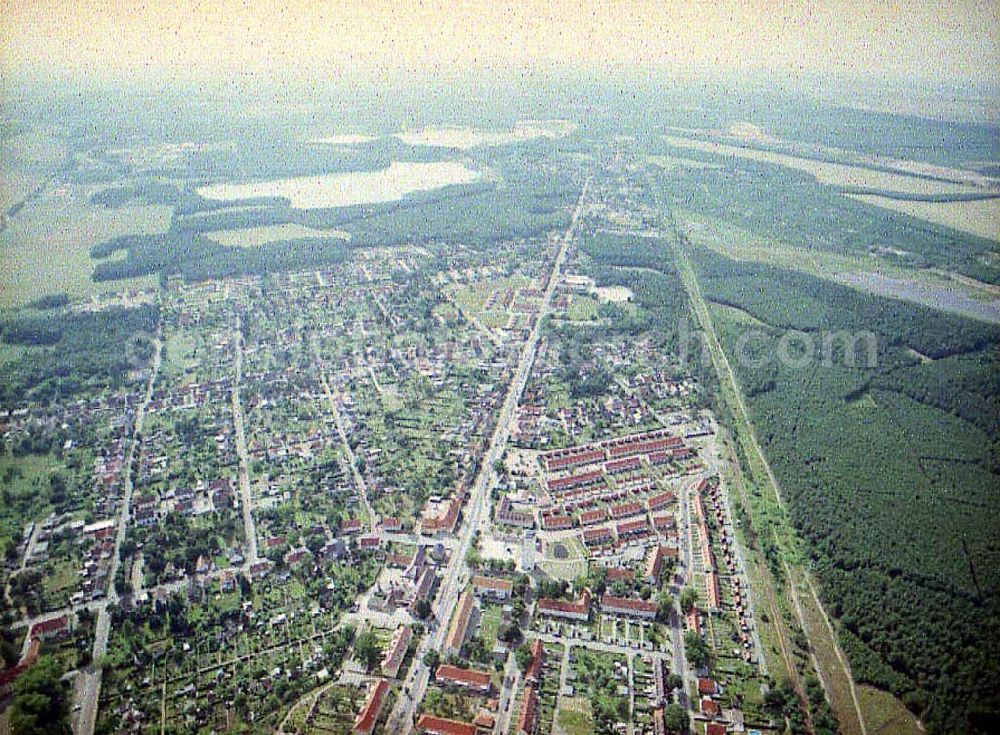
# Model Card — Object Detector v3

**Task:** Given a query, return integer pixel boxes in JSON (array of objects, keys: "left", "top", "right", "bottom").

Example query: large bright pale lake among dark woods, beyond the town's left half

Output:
[{"left": 198, "top": 161, "right": 481, "bottom": 209}]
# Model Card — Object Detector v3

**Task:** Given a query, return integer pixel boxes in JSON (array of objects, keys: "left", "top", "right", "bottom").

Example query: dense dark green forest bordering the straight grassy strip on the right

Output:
[{"left": 690, "top": 248, "right": 1000, "bottom": 732}]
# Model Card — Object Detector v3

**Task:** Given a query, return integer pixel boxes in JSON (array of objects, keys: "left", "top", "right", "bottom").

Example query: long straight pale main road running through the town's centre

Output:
[{"left": 387, "top": 179, "right": 590, "bottom": 735}]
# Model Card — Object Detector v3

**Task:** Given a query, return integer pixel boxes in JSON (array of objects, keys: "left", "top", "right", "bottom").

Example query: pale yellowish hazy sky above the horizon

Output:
[{"left": 0, "top": 0, "right": 1000, "bottom": 84}]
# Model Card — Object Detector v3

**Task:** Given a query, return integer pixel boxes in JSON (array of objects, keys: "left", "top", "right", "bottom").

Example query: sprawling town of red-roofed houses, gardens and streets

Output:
[{"left": 0, "top": 145, "right": 783, "bottom": 735}]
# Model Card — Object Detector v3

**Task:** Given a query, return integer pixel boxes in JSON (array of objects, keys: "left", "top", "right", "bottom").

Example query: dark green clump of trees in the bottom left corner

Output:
[{"left": 10, "top": 656, "right": 70, "bottom": 735}]
